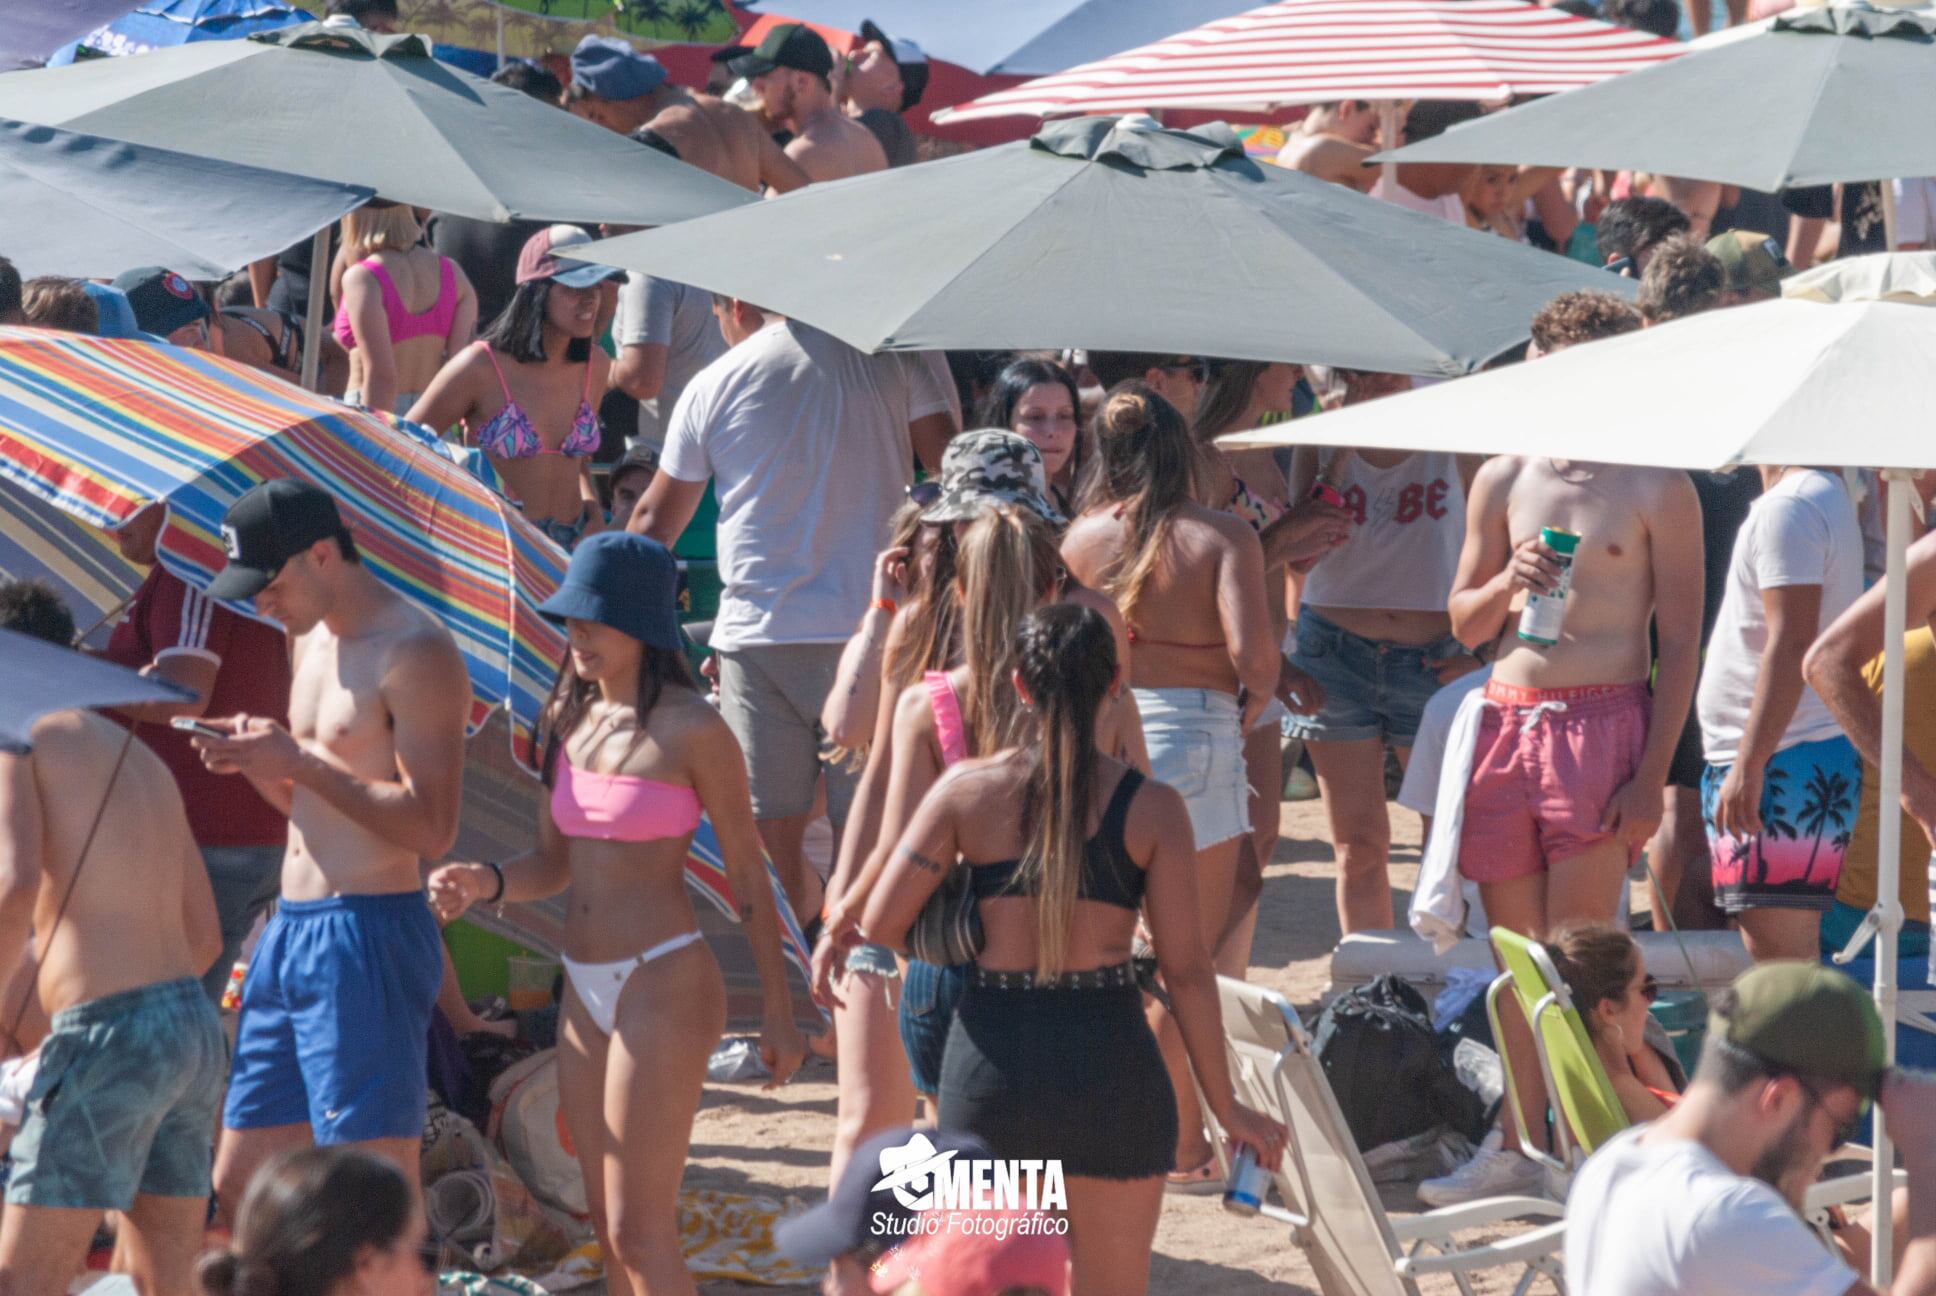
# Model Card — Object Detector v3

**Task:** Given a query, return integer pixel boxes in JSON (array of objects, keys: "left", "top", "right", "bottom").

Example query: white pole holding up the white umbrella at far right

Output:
[{"left": 1870, "top": 469, "right": 1911, "bottom": 1290}]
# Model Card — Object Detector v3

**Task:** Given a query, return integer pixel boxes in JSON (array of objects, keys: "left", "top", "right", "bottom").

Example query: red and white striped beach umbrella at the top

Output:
[{"left": 935, "top": 0, "right": 1684, "bottom": 122}]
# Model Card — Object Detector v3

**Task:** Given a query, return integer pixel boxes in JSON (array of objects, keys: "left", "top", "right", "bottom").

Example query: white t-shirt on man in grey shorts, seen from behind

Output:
[{"left": 658, "top": 320, "right": 954, "bottom": 649}]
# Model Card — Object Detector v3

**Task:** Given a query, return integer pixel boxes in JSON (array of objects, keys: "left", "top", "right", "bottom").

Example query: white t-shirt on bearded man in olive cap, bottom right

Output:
[{"left": 1564, "top": 1126, "right": 1857, "bottom": 1296}]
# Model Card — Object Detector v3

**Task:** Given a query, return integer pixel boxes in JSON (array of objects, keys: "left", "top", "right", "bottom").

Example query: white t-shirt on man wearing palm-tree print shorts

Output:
[{"left": 1694, "top": 469, "right": 1862, "bottom": 765}]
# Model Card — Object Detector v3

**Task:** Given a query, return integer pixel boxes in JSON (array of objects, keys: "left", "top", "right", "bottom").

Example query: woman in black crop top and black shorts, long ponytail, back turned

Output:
[{"left": 862, "top": 604, "right": 1286, "bottom": 1296}]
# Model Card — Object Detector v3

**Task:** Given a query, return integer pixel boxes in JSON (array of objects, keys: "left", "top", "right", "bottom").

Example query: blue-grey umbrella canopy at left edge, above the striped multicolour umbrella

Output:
[{"left": 0, "top": 120, "right": 370, "bottom": 279}]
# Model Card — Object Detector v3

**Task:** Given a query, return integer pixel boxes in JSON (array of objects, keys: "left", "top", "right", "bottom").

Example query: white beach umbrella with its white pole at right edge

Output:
[{"left": 1220, "top": 252, "right": 1936, "bottom": 1286}]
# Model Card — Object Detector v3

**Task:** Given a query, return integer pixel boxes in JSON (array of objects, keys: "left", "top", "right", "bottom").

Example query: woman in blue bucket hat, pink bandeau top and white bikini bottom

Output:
[{"left": 430, "top": 531, "right": 805, "bottom": 1296}]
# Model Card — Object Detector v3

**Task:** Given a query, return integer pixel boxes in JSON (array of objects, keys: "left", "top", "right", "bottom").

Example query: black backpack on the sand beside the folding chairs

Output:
[{"left": 1313, "top": 974, "right": 1485, "bottom": 1151}]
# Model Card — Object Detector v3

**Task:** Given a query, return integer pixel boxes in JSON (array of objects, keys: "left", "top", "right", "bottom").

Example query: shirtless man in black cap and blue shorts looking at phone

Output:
[{"left": 196, "top": 478, "right": 470, "bottom": 1220}]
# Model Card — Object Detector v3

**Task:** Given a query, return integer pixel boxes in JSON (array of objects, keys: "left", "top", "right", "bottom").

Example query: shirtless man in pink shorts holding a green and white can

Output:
[{"left": 1419, "top": 293, "right": 1704, "bottom": 1207}]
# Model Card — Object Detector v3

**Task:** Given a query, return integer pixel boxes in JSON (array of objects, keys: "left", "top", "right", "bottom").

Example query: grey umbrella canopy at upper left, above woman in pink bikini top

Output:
[{"left": 0, "top": 23, "right": 755, "bottom": 225}]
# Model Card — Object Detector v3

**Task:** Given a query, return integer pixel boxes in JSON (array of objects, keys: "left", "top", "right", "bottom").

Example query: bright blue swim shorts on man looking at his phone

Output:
[{"left": 223, "top": 891, "right": 443, "bottom": 1145}]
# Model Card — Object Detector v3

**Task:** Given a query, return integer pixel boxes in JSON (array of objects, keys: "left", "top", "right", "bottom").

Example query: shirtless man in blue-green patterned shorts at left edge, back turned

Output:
[{"left": 0, "top": 581, "right": 227, "bottom": 1296}]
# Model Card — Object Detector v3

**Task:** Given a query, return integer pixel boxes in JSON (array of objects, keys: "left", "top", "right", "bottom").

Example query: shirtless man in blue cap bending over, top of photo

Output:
[{"left": 565, "top": 37, "right": 807, "bottom": 194}]
